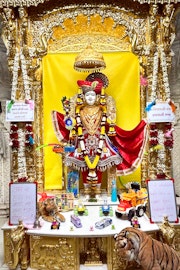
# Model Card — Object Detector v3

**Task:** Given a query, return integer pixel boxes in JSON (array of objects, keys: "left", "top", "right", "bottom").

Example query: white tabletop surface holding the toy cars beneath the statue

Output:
[{"left": 2, "top": 205, "right": 159, "bottom": 237}]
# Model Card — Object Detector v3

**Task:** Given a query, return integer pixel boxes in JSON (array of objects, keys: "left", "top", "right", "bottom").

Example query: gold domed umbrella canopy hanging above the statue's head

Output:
[{"left": 74, "top": 45, "right": 106, "bottom": 72}]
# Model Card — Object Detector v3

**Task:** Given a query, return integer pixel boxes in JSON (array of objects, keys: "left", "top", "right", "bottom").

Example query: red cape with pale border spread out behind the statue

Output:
[{"left": 52, "top": 111, "right": 148, "bottom": 182}]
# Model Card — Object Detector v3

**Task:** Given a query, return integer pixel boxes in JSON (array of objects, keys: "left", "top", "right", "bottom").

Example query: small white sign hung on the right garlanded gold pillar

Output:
[{"left": 147, "top": 102, "right": 175, "bottom": 123}]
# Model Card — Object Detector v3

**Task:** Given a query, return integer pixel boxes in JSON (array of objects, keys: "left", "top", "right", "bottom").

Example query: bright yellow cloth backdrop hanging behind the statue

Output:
[{"left": 43, "top": 52, "right": 140, "bottom": 189}]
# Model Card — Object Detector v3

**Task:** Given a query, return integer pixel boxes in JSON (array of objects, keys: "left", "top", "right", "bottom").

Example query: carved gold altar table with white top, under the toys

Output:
[{"left": 2, "top": 204, "right": 162, "bottom": 270}]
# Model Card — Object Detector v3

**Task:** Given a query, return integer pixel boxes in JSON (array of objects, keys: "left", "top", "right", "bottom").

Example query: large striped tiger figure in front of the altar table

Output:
[{"left": 114, "top": 227, "right": 180, "bottom": 270}]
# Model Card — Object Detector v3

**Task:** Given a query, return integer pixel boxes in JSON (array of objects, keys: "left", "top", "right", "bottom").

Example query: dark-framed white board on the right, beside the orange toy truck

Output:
[{"left": 147, "top": 179, "right": 178, "bottom": 223}]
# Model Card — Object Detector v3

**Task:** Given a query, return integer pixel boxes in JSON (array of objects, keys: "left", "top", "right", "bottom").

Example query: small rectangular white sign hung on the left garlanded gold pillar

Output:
[{"left": 6, "top": 100, "right": 34, "bottom": 122}]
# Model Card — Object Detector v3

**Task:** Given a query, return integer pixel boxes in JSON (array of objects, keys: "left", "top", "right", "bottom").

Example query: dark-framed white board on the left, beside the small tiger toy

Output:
[{"left": 9, "top": 183, "right": 37, "bottom": 225}]
